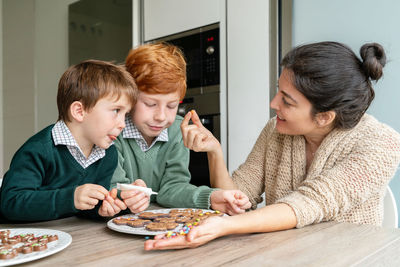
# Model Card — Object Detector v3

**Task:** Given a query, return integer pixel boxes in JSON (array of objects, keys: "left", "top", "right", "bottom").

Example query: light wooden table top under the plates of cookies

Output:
[{"left": 1, "top": 214, "right": 400, "bottom": 267}]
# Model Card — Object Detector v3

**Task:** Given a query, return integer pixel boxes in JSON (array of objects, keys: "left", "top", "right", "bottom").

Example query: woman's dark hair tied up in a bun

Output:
[{"left": 281, "top": 42, "right": 386, "bottom": 129}]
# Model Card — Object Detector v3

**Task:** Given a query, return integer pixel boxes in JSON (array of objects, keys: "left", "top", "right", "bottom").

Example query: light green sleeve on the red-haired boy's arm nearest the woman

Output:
[{"left": 157, "top": 134, "right": 214, "bottom": 209}]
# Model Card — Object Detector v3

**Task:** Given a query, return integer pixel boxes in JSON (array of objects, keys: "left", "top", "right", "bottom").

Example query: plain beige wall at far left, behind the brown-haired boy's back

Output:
[{"left": 1, "top": 0, "right": 76, "bottom": 175}]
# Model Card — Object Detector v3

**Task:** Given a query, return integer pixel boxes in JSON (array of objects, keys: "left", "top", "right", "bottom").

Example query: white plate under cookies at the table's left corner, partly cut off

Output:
[{"left": 0, "top": 228, "right": 72, "bottom": 266}]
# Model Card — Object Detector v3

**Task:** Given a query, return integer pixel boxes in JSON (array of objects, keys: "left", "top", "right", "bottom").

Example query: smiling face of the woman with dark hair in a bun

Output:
[{"left": 271, "top": 69, "right": 318, "bottom": 135}]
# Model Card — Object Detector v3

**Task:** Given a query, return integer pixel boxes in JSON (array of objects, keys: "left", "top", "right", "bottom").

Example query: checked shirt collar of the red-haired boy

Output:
[{"left": 122, "top": 115, "right": 168, "bottom": 152}]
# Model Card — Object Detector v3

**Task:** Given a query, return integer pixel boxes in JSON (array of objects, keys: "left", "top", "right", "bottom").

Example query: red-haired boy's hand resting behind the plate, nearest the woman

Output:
[{"left": 210, "top": 190, "right": 251, "bottom": 215}]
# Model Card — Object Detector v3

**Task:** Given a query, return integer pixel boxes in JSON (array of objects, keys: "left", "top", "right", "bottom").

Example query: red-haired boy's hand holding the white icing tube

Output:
[{"left": 121, "top": 179, "right": 150, "bottom": 213}]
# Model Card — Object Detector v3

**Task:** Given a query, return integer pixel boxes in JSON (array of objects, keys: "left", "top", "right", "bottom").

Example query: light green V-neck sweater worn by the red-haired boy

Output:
[{"left": 111, "top": 116, "right": 213, "bottom": 209}]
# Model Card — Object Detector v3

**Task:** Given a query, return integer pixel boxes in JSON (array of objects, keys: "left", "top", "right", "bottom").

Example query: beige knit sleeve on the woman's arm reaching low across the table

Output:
[{"left": 277, "top": 125, "right": 400, "bottom": 228}]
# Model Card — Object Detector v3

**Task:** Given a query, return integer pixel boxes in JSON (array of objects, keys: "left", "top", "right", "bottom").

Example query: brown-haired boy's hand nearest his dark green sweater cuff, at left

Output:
[{"left": 74, "top": 184, "right": 108, "bottom": 210}]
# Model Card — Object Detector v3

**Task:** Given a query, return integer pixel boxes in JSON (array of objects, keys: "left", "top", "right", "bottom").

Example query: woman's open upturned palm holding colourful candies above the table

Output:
[{"left": 144, "top": 217, "right": 226, "bottom": 250}]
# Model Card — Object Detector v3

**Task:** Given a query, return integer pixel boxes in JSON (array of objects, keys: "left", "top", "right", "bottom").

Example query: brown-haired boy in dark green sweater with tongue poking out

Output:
[{"left": 0, "top": 60, "right": 137, "bottom": 221}]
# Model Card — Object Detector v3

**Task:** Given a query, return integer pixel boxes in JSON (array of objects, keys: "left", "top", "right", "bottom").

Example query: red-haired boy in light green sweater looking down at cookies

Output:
[{"left": 111, "top": 43, "right": 250, "bottom": 214}]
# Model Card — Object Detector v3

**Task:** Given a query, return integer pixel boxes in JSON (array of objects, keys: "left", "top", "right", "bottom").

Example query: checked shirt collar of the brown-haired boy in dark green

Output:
[{"left": 51, "top": 121, "right": 106, "bottom": 169}]
